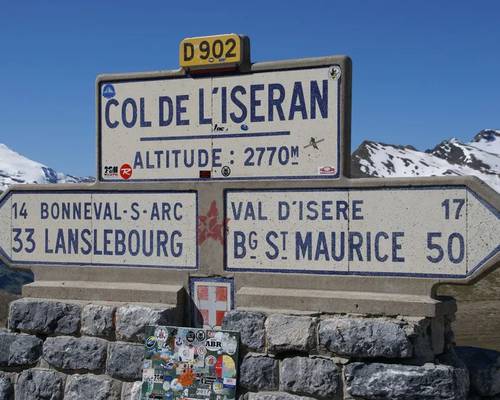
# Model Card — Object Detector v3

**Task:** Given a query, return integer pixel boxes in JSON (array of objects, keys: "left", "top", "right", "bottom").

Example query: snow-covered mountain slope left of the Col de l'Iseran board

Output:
[{"left": 0, "top": 143, "right": 93, "bottom": 191}]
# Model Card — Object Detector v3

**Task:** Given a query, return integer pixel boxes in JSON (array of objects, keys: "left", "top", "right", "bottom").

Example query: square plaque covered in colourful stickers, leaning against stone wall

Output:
[{"left": 141, "top": 326, "right": 239, "bottom": 400}]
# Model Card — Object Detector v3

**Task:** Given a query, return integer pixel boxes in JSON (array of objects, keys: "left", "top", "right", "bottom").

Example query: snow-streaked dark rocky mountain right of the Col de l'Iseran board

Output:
[{"left": 351, "top": 129, "right": 500, "bottom": 192}]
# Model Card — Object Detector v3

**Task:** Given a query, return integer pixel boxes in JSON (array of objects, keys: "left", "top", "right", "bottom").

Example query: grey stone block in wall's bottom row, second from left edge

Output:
[{"left": 15, "top": 369, "right": 64, "bottom": 400}]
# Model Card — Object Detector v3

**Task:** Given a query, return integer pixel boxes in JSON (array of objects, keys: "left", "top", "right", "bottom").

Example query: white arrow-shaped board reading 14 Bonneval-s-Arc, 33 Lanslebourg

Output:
[{"left": 0, "top": 189, "right": 198, "bottom": 269}]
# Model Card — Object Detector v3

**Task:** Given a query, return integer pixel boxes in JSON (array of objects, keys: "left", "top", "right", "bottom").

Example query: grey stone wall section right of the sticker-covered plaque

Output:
[{"left": 224, "top": 311, "right": 469, "bottom": 400}]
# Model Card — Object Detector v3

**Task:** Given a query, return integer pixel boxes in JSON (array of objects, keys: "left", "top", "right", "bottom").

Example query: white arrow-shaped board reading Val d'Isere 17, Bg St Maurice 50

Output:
[{"left": 225, "top": 187, "right": 500, "bottom": 278}]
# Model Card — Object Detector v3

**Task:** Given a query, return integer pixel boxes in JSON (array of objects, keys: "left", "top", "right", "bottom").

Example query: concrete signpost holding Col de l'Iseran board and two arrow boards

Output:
[{"left": 0, "top": 50, "right": 500, "bottom": 318}]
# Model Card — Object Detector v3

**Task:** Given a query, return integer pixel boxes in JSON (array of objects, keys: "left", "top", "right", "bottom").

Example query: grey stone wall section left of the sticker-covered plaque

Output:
[{"left": 0, "top": 298, "right": 182, "bottom": 400}]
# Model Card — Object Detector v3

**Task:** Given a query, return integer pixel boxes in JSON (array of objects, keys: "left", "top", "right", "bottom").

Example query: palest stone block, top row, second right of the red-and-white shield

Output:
[{"left": 266, "top": 314, "right": 315, "bottom": 353}]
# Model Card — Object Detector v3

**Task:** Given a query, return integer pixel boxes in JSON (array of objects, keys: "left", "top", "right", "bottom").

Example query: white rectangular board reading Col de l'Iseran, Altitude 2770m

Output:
[{"left": 98, "top": 66, "right": 341, "bottom": 182}]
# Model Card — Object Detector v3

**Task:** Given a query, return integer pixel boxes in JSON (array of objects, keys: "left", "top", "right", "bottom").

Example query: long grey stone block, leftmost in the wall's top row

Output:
[{"left": 9, "top": 298, "right": 81, "bottom": 335}]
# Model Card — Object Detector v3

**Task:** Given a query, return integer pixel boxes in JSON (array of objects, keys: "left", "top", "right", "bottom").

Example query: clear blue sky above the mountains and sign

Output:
[{"left": 0, "top": 0, "right": 500, "bottom": 175}]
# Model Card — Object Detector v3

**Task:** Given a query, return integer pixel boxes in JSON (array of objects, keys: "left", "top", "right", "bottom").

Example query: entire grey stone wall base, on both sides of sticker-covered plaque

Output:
[{"left": 0, "top": 298, "right": 500, "bottom": 400}]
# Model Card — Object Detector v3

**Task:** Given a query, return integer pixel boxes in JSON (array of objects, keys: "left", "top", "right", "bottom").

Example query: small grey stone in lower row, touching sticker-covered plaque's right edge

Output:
[{"left": 239, "top": 353, "right": 279, "bottom": 391}]
